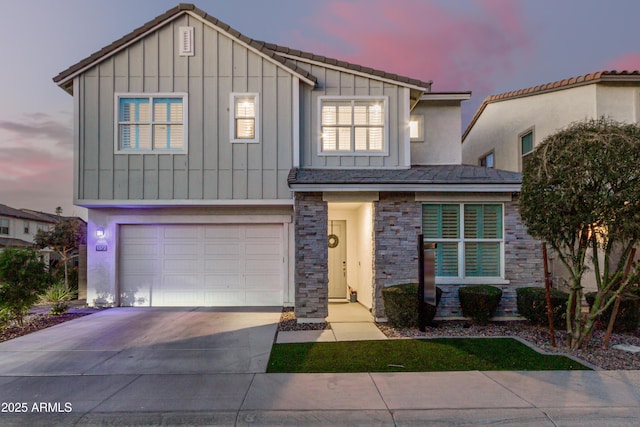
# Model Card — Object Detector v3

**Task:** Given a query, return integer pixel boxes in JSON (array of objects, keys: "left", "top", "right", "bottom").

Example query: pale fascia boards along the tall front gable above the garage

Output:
[{"left": 56, "top": 10, "right": 316, "bottom": 93}]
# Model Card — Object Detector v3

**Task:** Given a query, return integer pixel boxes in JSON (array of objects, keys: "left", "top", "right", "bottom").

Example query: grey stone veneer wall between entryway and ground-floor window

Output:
[{"left": 373, "top": 193, "right": 422, "bottom": 318}]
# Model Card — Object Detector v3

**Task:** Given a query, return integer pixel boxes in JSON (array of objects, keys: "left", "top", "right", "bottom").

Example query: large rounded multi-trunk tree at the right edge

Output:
[{"left": 520, "top": 118, "right": 640, "bottom": 348}]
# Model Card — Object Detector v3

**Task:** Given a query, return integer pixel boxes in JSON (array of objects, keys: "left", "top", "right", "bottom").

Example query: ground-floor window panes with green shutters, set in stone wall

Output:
[{"left": 422, "top": 203, "right": 504, "bottom": 279}]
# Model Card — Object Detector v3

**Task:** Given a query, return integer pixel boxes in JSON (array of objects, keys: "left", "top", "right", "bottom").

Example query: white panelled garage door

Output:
[{"left": 119, "top": 224, "right": 284, "bottom": 306}]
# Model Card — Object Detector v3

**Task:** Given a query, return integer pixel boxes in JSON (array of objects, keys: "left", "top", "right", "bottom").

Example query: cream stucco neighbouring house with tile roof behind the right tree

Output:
[{"left": 462, "top": 71, "right": 640, "bottom": 289}]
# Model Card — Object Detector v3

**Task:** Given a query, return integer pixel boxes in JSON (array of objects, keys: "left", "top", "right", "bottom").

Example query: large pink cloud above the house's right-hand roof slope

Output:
[{"left": 292, "top": 0, "right": 531, "bottom": 91}]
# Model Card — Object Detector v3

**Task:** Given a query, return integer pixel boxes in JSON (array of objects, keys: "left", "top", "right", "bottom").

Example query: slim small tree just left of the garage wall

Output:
[{"left": 34, "top": 207, "right": 84, "bottom": 286}]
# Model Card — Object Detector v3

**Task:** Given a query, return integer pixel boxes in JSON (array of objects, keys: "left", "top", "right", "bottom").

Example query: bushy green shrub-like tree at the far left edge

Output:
[{"left": 0, "top": 248, "right": 51, "bottom": 325}]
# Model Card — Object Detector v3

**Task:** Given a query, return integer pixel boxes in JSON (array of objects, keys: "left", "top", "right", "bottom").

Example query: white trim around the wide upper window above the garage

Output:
[{"left": 113, "top": 92, "right": 189, "bottom": 154}]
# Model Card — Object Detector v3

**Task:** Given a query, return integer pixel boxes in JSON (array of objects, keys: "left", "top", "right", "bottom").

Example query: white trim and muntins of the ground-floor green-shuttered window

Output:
[{"left": 420, "top": 201, "right": 509, "bottom": 284}]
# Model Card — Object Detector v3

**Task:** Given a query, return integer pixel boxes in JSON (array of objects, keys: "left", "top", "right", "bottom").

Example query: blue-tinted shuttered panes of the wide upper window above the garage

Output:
[{"left": 116, "top": 94, "right": 187, "bottom": 152}]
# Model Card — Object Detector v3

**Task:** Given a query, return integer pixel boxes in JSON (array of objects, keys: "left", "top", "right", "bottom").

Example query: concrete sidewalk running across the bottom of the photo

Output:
[{"left": 0, "top": 371, "right": 640, "bottom": 426}]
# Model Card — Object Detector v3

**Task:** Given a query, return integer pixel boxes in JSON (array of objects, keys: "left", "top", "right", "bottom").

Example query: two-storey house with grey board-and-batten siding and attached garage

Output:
[{"left": 54, "top": 4, "right": 543, "bottom": 322}]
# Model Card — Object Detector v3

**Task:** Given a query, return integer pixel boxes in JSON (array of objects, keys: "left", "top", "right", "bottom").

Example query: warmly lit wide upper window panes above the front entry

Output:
[{"left": 320, "top": 97, "right": 388, "bottom": 155}]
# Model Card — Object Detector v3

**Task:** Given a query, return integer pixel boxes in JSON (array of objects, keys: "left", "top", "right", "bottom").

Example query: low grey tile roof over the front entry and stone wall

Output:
[{"left": 287, "top": 165, "right": 522, "bottom": 185}]
